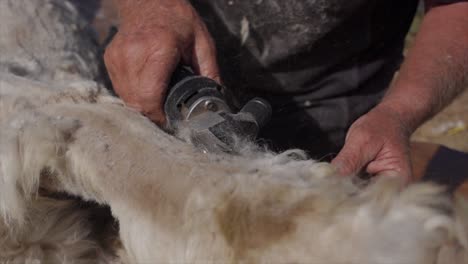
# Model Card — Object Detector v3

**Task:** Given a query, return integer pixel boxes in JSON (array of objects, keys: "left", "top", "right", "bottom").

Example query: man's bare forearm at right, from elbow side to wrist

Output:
[{"left": 379, "top": 2, "right": 468, "bottom": 132}]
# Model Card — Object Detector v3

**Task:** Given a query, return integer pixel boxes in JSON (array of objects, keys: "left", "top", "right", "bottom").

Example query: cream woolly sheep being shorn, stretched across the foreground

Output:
[{"left": 0, "top": 0, "right": 468, "bottom": 264}]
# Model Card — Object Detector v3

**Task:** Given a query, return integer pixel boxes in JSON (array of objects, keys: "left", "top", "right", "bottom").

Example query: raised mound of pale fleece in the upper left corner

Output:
[{"left": 0, "top": 0, "right": 98, "bottom": 83}]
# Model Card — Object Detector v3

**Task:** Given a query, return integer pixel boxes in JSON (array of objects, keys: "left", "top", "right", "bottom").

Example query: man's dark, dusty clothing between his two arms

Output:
[{"left": 192, "top": 0, "right": 418, "bottom": 158}]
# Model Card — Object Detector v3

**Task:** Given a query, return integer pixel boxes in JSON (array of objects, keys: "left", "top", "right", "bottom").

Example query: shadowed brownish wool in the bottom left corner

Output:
[{"left": 0, "top": 198, "right": 100, "bottom": 263}]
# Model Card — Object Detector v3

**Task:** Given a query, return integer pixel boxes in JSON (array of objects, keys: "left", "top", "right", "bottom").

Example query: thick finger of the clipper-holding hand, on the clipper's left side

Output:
[{"left": 135, "top": 43, "right": 180, "bottom": 125}]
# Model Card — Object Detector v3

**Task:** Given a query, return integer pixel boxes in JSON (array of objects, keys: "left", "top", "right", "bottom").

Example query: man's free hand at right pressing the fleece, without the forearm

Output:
[{"left": 332, "top": 106, "right": 412, "bottom": 182}]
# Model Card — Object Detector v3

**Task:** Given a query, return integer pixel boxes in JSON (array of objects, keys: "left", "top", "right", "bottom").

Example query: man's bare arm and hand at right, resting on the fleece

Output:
[{"left": 333, "top": 0, "right": 468, "bottom": 180}]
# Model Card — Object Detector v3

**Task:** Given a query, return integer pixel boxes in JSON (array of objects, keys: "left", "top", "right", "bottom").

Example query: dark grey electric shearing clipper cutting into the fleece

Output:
[{"left": 164, "top": 67, "right": 272, "bottom": 153}]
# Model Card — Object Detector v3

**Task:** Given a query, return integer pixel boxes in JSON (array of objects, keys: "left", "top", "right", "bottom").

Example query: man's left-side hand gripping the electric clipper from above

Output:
[{"left": 104, "top": 0, "right": 220, "bottom": 124}]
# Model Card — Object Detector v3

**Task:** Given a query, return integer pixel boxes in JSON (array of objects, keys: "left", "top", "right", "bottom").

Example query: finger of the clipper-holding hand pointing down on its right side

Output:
[{"left": 192, "top": 27, "right": 221, "bottom": 82}]
